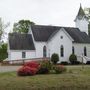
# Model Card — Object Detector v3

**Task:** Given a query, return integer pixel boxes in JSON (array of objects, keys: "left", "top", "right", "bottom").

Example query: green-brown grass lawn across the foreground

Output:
[{"left": 0, "top": 66, "right": 90, "bottom": 90}]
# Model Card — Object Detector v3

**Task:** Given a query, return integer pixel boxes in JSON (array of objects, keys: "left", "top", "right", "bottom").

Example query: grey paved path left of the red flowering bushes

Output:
[{"left": 0, "top": 66, "right": 21, "bottom": 73}]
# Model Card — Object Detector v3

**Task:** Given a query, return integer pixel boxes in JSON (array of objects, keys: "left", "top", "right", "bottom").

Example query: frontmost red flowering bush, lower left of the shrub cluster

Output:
[{"left": 17, "top": 66, "right": 37, "bottom": 76}]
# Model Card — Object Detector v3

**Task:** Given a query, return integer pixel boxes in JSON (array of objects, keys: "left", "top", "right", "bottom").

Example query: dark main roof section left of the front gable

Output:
[{"left": 31, "top": 25, "right": 60, "bottom": 41}]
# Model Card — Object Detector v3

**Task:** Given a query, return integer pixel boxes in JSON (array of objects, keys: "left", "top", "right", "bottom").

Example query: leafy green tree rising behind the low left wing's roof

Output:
[{"left": 13, "top": 20, "right": 35, "bottom": 33}]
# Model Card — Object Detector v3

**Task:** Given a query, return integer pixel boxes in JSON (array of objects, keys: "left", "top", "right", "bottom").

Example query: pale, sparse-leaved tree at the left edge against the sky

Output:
[{"left": 0, "top": 18, "right": 10, "bottom": 41}]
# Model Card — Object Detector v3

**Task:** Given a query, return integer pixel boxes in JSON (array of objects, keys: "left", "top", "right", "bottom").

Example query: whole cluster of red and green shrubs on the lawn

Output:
[{"left": 17, "top": 60, "right": 66, "bottom": 76}]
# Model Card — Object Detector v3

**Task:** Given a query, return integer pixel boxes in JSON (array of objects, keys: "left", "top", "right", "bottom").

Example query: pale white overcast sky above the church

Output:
[{"left": 0, "top": 0, "right": 90, "bottom": 31}]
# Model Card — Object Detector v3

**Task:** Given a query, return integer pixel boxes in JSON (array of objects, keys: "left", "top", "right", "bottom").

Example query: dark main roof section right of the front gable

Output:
[{"left": 65, "top": 27, "right": 90, "bottom": 43}]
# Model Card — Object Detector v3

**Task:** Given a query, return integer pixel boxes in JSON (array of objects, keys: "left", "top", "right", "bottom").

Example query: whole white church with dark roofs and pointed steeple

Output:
[{"left": 8, "top": 6, "right": 90, "bottom": 62}]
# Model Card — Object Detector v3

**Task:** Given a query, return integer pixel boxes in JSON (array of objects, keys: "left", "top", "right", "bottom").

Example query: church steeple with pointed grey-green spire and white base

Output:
[{"left": 75, "top": 4, "right": 89, "bottom": 34}]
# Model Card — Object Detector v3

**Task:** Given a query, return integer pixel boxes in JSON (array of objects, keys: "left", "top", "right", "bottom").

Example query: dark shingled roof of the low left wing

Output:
[{"left": 9, "top": 33, "right": 35, "bottom": 50}]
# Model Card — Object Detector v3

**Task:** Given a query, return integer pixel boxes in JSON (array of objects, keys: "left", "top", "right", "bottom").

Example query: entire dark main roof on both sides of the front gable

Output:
[{"left": 31, "top": 25, "right": 90, "bottom": 43}]
